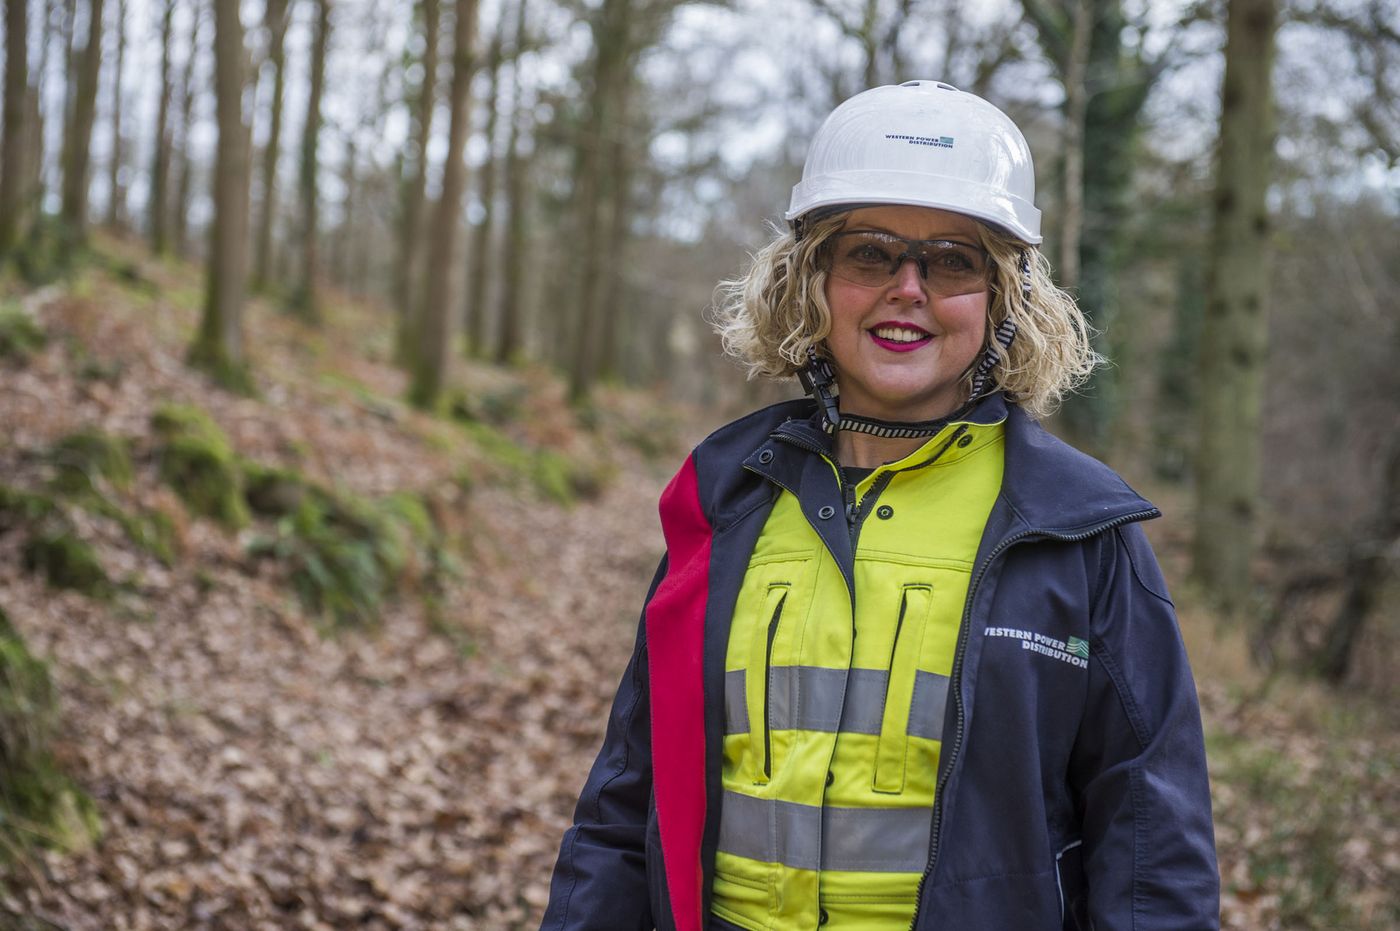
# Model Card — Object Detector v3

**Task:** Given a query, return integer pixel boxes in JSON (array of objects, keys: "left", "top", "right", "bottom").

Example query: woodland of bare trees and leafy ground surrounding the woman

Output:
[{"left": 0, "top": 0, "right": 1400, "bottom": 931}]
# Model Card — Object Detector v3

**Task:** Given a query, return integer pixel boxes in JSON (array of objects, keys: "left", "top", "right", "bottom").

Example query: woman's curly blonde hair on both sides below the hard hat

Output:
[{"left": 710, "top": 211, "right": 1103, "bottom": 417}]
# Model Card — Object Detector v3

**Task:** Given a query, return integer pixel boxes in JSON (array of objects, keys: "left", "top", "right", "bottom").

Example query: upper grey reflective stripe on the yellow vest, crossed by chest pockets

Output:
[{"left": 724, "top": 666, "right": 948, "bottom": 741}]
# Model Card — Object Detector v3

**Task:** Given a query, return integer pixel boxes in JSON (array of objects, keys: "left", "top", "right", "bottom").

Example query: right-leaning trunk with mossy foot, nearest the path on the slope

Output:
[{"left": 409, "top": 0, "right": 476, "bottom": 409}]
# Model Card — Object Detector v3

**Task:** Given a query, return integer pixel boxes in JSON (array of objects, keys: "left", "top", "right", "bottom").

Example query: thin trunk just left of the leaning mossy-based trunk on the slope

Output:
[{"left": 393, "top": 0, "right": 441, "bottom": 368}]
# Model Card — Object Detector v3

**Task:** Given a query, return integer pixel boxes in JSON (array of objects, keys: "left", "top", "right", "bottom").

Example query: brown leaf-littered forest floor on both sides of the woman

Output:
[{"left": 0, "top": 241, "right": 1400, "bottom": 931}]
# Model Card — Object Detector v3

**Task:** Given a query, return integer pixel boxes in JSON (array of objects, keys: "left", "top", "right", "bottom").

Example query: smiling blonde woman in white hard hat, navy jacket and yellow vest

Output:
[{"left": 543, "top": 81, "right": 1218, "bottom": 931}]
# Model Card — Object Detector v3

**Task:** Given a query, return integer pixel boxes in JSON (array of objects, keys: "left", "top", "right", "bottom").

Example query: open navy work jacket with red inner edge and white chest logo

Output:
[{"left": 542, "top": 396, "right": 1219, "bottom": 931}]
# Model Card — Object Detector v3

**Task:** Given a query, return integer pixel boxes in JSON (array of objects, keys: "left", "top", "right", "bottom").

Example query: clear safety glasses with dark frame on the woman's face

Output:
[{"left": 825, "top": 230, "right": 990, "bottom": 297}]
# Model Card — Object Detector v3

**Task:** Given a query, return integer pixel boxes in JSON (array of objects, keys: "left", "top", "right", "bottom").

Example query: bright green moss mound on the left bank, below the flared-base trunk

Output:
[{"left": 151, "top": 405, "right": 248, "bottom": 529}]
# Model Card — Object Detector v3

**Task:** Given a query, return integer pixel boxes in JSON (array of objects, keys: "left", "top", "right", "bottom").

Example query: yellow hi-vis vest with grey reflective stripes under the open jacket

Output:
[{"left": 713, "top": 423, "right": 1004, "bottom": 931}]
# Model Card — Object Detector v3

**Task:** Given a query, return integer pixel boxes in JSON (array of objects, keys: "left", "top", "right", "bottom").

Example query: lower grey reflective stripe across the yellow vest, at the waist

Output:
[{"left": 720, "top": 792, "right": 932, "bottom": 872}]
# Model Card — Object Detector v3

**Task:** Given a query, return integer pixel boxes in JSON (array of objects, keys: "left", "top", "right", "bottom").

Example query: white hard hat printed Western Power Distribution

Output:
[{"left": 784, "top": 81, "right": 1042, "bottom": 245}]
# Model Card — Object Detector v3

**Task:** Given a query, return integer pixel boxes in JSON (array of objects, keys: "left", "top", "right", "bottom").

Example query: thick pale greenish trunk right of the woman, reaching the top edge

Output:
[{"left": 1191, "top": 0, "right": 1277, "bottom": 613}]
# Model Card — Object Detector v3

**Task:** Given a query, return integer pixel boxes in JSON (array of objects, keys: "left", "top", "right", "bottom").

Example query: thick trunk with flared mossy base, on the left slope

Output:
[{"left": 190, "top": 0, "right": 249, "bottom": 388}]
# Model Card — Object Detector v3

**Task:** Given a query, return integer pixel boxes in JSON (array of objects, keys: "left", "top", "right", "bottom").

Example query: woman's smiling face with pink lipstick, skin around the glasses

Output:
[{"left": 826, "top": 206, "right": 988, "bottom": 420}]
